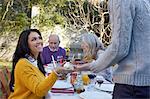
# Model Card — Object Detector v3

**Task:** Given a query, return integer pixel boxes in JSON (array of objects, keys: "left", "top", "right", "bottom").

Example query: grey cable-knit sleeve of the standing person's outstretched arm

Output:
[{"left": 90, "top": 0, "right": 135, "bottom": 73}]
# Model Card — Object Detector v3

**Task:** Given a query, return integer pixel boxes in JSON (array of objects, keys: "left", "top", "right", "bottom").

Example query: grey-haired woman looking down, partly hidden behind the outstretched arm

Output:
[{"left": 81, "top": 33, "right": 112, "bottom": 82}]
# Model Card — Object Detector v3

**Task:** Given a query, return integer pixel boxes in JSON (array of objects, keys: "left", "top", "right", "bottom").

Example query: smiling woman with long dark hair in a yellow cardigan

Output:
[{"left": 9, "top": 29, "right": 69, "bottom": 99}]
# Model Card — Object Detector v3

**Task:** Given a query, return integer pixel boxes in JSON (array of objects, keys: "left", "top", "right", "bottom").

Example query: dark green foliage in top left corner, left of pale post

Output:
[{"left": 0, "top": 0, "right": 30, "bottom": 38}]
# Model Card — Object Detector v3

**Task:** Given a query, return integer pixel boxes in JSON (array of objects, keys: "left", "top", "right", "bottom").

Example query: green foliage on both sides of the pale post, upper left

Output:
[{"left": 0, "top": 0, "right": 67, "bottom": 37}]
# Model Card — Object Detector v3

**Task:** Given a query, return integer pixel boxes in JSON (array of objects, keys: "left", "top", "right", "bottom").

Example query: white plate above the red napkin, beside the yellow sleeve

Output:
[{"left": 52, "top": 80, "right": 73, "bottom": 88}]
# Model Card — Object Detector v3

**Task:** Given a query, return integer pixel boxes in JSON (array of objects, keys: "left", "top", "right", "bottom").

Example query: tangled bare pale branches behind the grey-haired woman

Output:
[{"left": 59, "top": 0, "right": 111, "bottom": 46}]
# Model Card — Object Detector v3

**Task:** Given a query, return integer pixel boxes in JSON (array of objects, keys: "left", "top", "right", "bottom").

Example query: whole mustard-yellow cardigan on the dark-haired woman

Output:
[{"left": 8, "top": 58, "right": 57, "bottom": 99}]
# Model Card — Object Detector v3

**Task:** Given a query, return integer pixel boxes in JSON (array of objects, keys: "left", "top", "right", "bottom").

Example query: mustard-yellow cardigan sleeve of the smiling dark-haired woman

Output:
[{"left": 16, "top": 59, "right": 57, "bottom": 97}]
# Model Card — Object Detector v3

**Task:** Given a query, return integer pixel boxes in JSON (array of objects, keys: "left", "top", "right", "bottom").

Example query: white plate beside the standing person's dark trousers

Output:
[{"left": 95, "top": 84, "right": 114, "bottom": 92}]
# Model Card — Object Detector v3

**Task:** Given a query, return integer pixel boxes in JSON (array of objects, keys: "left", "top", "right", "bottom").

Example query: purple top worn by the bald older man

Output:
[{"left": 42, "top": 46, "right": 66, "bottom": 65}]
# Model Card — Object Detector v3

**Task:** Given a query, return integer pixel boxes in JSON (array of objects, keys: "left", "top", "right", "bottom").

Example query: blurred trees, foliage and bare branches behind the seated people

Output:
[{"left": 0, "top": 0, "right": 111, "bottom": 61}]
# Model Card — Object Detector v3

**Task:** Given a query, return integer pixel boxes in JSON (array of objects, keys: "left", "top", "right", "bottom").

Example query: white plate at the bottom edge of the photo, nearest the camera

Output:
[{"left": 79, "top": 91, "right": 112, "bottom": 99}]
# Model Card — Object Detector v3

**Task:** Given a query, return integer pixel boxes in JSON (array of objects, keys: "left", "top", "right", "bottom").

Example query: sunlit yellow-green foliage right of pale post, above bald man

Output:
[{"left": 32, "top": 4, "right": 64, "bottom": 29}]
